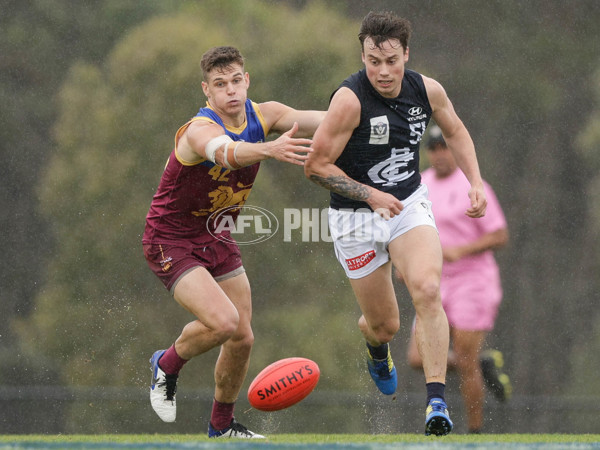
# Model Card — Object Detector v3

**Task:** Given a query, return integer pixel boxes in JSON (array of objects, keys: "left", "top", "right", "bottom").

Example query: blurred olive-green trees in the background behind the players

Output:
[{"left": 0, "top": 0, "right": 600, "bottom": 432}]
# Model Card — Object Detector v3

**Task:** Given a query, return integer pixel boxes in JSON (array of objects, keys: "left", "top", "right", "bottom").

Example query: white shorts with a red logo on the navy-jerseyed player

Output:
[{"left": 329, "top": 184, "right": 437, "bottom": 279}]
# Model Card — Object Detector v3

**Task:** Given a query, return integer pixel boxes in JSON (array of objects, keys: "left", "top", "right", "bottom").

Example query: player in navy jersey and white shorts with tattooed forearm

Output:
[{"left": 304, "top": 12, "right": 486, "bottom": 435}]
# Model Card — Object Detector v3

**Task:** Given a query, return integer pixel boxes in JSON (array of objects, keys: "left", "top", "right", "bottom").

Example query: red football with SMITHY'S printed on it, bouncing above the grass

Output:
[{"left": 248, "top": 358, "right": 321, "bottom": 411}]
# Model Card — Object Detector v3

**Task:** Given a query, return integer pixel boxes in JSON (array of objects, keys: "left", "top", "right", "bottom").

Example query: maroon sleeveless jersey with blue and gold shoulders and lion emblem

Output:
[{"left": 142, "top": 100, "right": 269, "bottom": 244}]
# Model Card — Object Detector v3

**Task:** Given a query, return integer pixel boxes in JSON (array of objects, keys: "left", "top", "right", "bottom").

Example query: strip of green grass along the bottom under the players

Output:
[{"left": 0, "top": 434, "right": 600, "bottom": 450}]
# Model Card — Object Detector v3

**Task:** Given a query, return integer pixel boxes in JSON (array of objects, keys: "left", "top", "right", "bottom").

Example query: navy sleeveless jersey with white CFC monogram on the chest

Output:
[{"left": 330, "top": 69, "right": 432, "bottom": 210}]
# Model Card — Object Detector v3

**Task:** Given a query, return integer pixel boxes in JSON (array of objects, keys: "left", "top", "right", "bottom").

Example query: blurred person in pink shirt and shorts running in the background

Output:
[{"left": 407, "top": 126, "right": 511, "bottom": 433}]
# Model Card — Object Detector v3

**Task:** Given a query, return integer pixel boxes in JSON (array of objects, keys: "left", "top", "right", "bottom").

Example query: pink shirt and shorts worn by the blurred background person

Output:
[{"left": 422, "top": 168, "right": 506, "bottom": 330}]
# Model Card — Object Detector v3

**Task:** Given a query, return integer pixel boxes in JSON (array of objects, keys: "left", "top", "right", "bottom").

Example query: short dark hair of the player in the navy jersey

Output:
[{"left": 358, "top": 11, "right": 412, "bottom": 51}]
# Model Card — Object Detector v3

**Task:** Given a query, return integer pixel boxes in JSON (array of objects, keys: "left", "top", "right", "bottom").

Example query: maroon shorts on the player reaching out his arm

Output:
[{"left": 144, "top": 239, "right": 245, "bottom": 293}]
